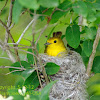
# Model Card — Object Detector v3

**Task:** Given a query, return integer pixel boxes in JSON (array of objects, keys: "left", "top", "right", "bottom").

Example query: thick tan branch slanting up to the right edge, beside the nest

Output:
[{"left": 86, "top": 24, "right": 100, "bottom": 76}]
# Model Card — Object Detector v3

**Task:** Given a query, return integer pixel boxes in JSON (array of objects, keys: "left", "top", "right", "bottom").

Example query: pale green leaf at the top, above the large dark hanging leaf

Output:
[{"left": 73, "top": 1, "right": 88, "bottom": 17}]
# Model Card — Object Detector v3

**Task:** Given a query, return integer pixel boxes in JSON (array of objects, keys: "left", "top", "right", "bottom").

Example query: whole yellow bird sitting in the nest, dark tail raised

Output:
[{"left": 44, "top": 32, "right": 68, "bottom": 57}]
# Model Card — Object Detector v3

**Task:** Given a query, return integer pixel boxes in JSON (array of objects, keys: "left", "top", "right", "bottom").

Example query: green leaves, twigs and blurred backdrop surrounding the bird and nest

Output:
[{"left": 0, "top": 0, "right": 100, "bottom": 100}]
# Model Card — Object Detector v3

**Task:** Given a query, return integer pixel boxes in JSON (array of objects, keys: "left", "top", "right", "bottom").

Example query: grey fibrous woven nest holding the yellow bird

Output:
[{"left": 40, "top": 51, "right": 88, "bottom": 100}]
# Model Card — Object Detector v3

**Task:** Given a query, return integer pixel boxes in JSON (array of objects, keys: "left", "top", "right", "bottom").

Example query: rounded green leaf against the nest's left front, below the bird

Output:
[{"left": 45, "top": 62, "right": 60, "bottom": 75}]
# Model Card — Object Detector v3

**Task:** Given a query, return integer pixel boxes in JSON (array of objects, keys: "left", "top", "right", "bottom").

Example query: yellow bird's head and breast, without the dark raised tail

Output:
[{"left": 45, "top": 37, "right": 67, "bottom": 56}]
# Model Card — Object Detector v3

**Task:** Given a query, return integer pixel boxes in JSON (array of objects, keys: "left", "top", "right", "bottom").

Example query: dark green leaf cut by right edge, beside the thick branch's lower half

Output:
[{"left": 92, "top": 56, "right": 100, "bottom": 73}]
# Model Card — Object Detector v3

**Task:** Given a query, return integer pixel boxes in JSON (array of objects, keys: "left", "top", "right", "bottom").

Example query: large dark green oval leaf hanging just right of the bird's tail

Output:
[{"left": 65, "top": 25, "right": 80, "bottom": 48}]
